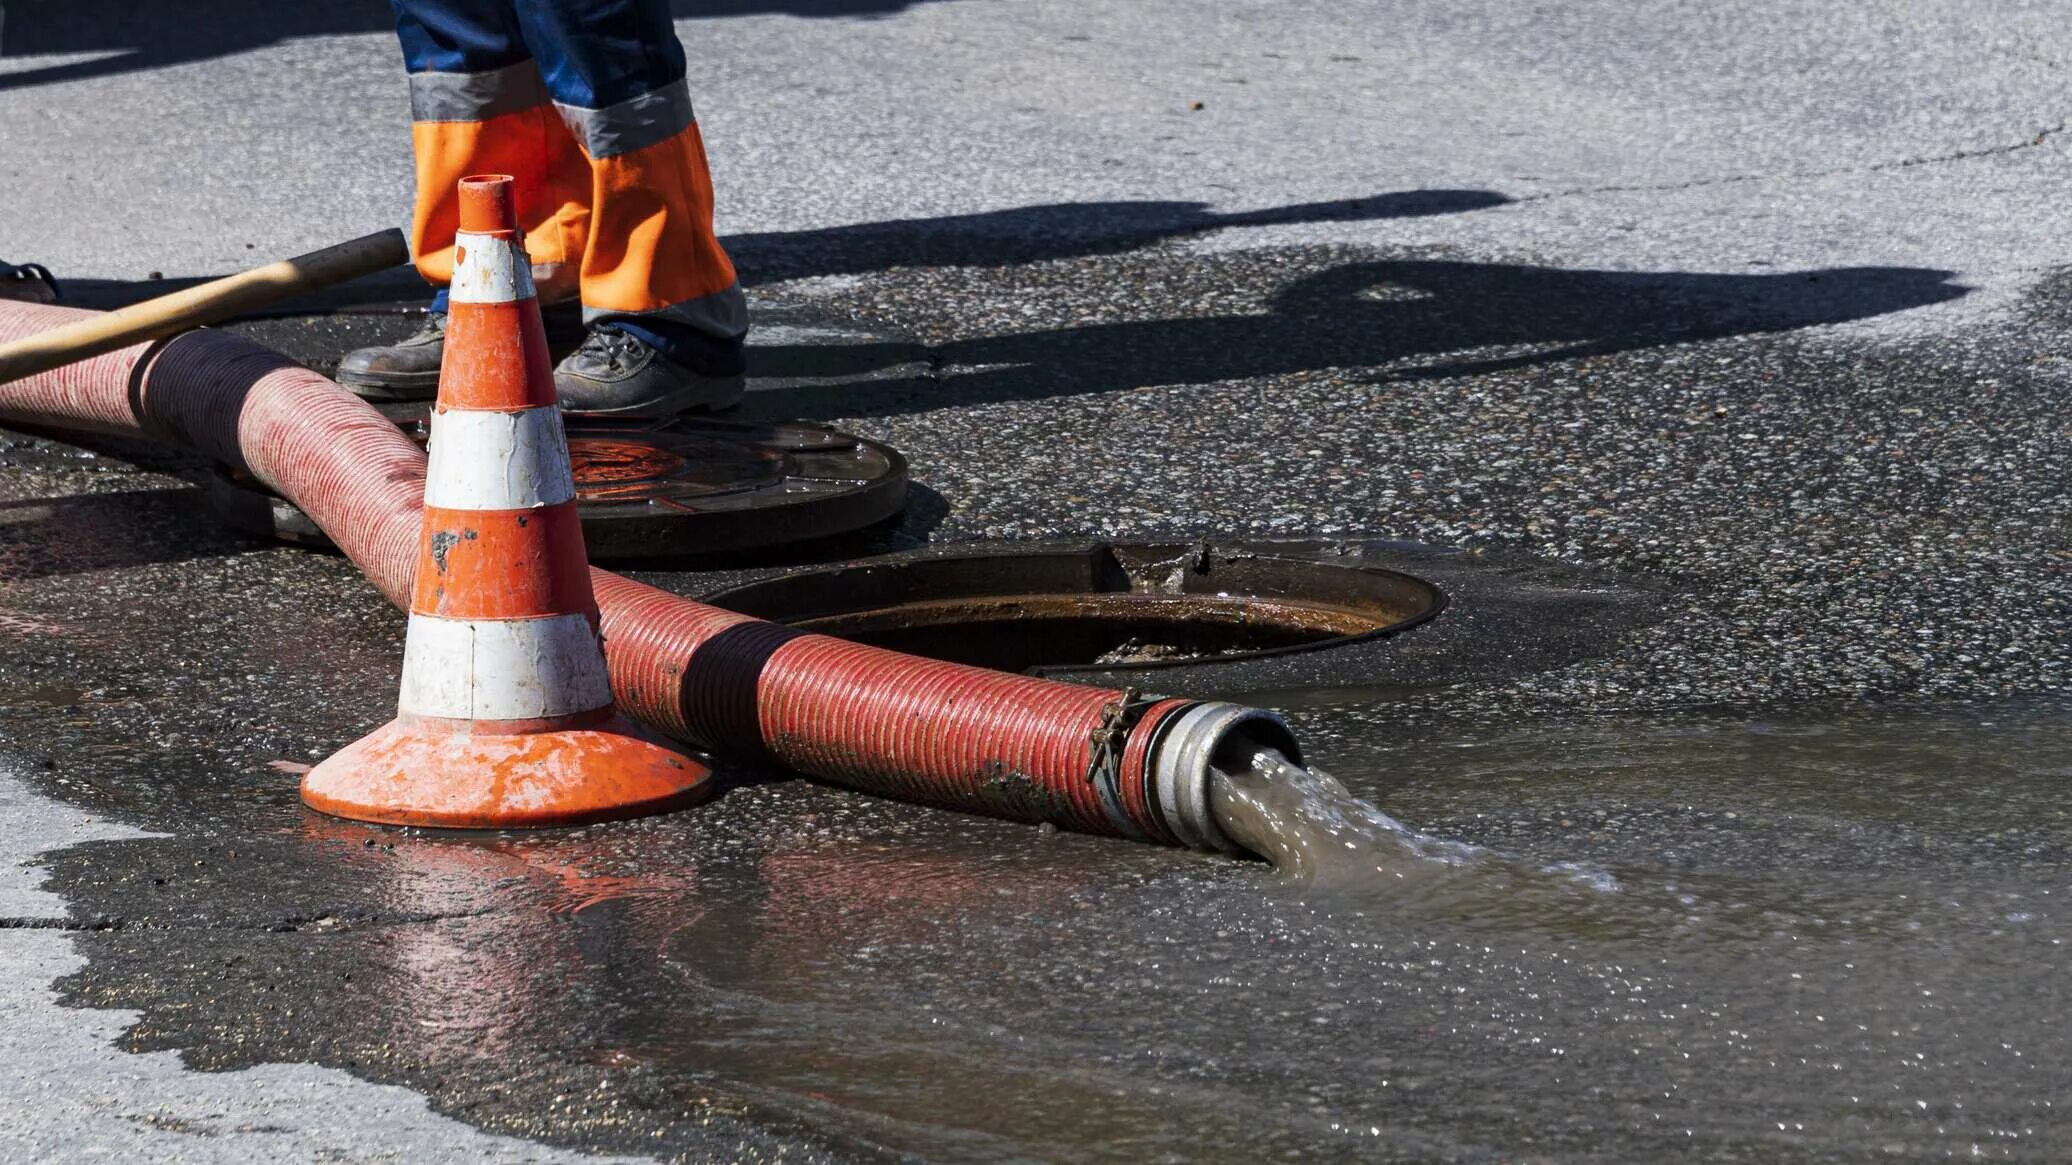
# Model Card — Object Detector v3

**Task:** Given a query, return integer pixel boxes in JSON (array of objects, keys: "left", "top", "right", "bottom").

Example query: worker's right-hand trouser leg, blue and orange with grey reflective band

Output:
[{"left": 516, "top": 0, "right": 748, "bottom": 404}]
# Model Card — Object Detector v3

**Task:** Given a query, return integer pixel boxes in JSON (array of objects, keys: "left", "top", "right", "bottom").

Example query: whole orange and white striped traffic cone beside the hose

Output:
[{"left": 303, "top": 174, "right": 711, "bottom": 829}]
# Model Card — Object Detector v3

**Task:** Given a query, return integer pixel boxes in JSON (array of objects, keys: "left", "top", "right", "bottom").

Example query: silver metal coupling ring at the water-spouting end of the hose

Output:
[{"left": 1150, "top": 701, "right": 1301, "bottom": 854}]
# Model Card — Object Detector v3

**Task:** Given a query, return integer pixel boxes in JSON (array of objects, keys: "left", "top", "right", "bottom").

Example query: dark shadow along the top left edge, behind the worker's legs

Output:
[{"left": 0, "top": 0, "right": 948, "bottom": 89}]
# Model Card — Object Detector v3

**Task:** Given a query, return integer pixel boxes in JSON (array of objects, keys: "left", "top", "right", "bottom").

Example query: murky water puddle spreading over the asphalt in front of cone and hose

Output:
[{"left": 20, "top": 703, "right": 2072, "bottom": 1163}]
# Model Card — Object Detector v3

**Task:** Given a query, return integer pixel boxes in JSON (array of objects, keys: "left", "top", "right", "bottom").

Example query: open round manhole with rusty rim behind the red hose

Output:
[{"left": 704, "top": 543, "right": 1446, "bottom": 676}]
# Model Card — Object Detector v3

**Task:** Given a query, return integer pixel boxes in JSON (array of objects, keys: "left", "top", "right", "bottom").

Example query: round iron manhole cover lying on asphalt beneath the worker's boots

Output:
[{"left": 209, "top": 406, "right": 908, "bottom": 560}]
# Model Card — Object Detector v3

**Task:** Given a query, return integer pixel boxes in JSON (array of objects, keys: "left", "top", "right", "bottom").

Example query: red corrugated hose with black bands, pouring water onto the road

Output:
[{"left": 0, "top": 301, "right": 1297, "bottom": 850}]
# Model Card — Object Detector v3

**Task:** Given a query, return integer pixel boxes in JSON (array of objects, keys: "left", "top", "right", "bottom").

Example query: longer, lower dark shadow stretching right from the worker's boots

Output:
[{"left": 756, "top": 249, "right": 1966, "bottom": 419}]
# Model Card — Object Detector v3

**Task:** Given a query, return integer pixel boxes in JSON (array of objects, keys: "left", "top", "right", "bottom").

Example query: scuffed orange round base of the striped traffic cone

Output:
[{"left": 303, "top": 715, "right": 713, "bottom": 829}]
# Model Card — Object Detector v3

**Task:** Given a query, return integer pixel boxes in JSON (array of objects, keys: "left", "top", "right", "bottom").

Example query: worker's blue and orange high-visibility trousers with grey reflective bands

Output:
[{"left": 392, "top": 0, "right": 748, "bottom": 373}]
